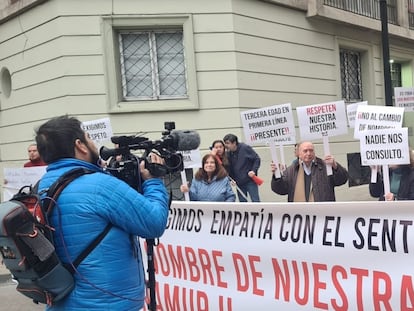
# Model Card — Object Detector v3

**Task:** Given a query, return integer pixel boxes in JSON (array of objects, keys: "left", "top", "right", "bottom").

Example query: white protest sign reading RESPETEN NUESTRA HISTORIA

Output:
[{"left": 296, "top": 100, "right": 348, "bottom": 140}]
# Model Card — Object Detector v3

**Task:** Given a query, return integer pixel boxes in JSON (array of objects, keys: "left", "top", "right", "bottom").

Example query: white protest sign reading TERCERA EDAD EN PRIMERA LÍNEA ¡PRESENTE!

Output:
[{"left": 240, "top": 103, "right": 296, "bottom": 145}]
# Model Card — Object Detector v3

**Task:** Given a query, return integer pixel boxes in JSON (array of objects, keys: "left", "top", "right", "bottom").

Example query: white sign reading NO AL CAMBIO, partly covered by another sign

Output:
[{"left": 354, "top": 105, "right": 404, "bottom": 139}]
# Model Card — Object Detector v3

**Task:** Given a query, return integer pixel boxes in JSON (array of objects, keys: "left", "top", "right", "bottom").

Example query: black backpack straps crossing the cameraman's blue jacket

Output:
[{"left": 45, "top": 168, "right": 112, "bottom": 274}]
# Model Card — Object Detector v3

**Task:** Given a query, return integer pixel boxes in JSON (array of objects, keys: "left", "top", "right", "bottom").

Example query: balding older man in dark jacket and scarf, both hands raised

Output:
[{"left": 271, "top": 141, "right": 348, "bottom": 202}]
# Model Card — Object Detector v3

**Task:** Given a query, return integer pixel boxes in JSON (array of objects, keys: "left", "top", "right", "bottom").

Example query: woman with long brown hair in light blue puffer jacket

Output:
[{"left": 180, "top": 154, "right": 236, "bottom": 202}]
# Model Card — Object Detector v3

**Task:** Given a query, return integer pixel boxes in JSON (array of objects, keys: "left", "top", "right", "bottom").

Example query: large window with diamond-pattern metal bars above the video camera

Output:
[{"left": 118, "top": 29, "right": 188, "bottom": 101}]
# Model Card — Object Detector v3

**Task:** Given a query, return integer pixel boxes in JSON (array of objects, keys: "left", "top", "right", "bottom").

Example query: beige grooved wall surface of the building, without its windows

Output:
[{"left": 0, "top": 0, "right": 414, "bottom": 201}]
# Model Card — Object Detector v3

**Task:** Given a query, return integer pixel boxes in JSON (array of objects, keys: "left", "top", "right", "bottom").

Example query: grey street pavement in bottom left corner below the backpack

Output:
[{"left": 0, "top": 264, "right": 45, "bottom": 311}]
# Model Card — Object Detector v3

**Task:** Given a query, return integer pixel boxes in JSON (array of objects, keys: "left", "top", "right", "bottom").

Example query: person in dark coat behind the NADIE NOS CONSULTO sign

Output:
[{"left": 369, "top": 150, "right": 414, "bottom": 201}]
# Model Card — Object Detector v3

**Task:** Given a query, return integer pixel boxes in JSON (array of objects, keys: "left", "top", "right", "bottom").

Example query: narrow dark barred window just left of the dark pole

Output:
[{"left": 339, "top": 49, "right": 363, "bottom": 103}]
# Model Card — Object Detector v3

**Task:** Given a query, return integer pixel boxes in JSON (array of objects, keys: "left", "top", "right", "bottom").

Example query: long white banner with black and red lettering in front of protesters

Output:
[{"left": 142, "top": 201, "right": 414, "bottom": 311}]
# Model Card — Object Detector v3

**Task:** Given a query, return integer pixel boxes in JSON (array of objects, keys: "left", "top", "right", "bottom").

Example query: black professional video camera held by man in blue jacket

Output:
[{"left": 99, "top": 122, "right": 200, "bottom": 190}]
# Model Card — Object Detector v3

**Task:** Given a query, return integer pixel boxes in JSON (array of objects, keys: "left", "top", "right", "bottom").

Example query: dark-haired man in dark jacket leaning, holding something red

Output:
[{"left": 223, "top": 134, "right": 261, "bottom": 202}]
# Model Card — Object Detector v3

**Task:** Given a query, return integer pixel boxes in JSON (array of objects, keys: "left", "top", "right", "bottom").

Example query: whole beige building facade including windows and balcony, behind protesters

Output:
[{"left": 0, "top": 0, "right": 414, "bottom": 201}]
